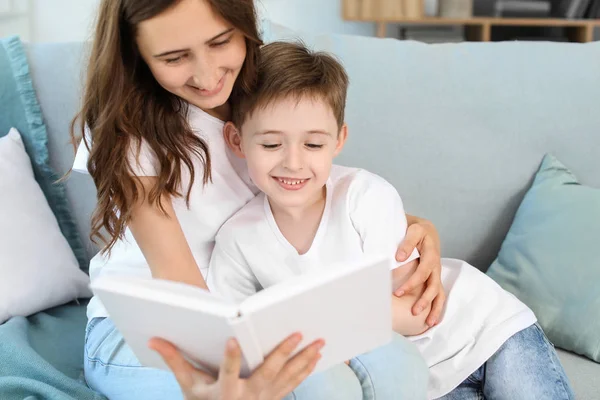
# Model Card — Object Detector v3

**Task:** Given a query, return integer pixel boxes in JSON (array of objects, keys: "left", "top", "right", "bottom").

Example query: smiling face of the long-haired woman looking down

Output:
[{"left": 136, "top": 0, "right": 246, "bottom": 117}]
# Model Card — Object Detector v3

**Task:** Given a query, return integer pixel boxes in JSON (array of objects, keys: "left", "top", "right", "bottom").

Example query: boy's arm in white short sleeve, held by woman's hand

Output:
[{"left": 348, "top": 171, "right": 429, "bottom": 336}]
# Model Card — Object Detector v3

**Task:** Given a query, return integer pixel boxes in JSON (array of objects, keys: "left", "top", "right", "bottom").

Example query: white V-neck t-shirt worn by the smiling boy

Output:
[{"left": 208, "top": 166, "right": 536, "bottom": 398}]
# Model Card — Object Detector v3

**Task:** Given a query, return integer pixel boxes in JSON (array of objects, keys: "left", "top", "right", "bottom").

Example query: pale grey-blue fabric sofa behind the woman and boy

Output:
[{"left": 28, "top": 32, "right": 600, "bottom": 400}]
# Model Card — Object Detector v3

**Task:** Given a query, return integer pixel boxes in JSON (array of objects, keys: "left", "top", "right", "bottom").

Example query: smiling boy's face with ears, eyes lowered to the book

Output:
[{"left": 226, "top": 98, "right": 347, "bottom": 208}]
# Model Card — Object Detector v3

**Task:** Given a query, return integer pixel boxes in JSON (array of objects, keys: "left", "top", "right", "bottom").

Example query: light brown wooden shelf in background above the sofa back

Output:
[{"left": 343, "top": 7, "right": 600, "bottom": 43}]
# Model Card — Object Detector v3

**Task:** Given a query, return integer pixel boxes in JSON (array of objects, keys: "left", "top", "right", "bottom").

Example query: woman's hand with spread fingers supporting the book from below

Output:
[{"left": 149, "top": 334, "right": 324, "bottom": 400}]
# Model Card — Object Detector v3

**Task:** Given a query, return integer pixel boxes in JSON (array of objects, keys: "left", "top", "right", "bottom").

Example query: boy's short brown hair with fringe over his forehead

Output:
[{"left": 231, "top": 42, "right": 348, "bottom": 128}]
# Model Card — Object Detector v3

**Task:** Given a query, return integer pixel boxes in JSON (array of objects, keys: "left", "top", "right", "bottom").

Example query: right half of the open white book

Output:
[{"left": 240, "top": 259, "right": 395, "bottom": 372}]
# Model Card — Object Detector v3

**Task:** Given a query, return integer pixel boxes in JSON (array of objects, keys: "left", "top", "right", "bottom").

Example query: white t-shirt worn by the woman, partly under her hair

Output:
[{"left": 73, "top": 105, "right": 258, "bottom": 319}]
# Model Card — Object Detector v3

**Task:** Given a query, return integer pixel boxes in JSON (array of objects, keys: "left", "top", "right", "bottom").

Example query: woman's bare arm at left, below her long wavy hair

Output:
[{"left": 129, "top": 177, "right": 207, "bottom": 289}]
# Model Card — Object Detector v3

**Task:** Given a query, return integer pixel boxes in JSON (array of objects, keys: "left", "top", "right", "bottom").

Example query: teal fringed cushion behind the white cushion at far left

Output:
[{"left": 0, "top": 36, "right": 87, "bottom": 270}]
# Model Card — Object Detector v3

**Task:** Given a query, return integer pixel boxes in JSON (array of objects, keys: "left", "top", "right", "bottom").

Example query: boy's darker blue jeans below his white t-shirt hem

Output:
[{"left": 441, "top": 324, "right": 575, "bottom": 400}]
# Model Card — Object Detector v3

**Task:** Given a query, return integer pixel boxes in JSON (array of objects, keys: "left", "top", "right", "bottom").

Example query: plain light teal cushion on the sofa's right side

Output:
[{"left": 488, "top": 155, "right": 600, "bottom": 362}]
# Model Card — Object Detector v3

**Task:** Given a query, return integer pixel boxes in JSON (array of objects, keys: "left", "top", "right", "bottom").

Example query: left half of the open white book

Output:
[{"left": 92, "top": 276, "right": 246, "bottom": 373}]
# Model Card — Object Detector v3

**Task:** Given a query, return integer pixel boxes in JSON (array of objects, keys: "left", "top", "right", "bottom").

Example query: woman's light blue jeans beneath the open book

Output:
[{"left": 84, "top": 318, "right": 428, "bottom": 400}]
